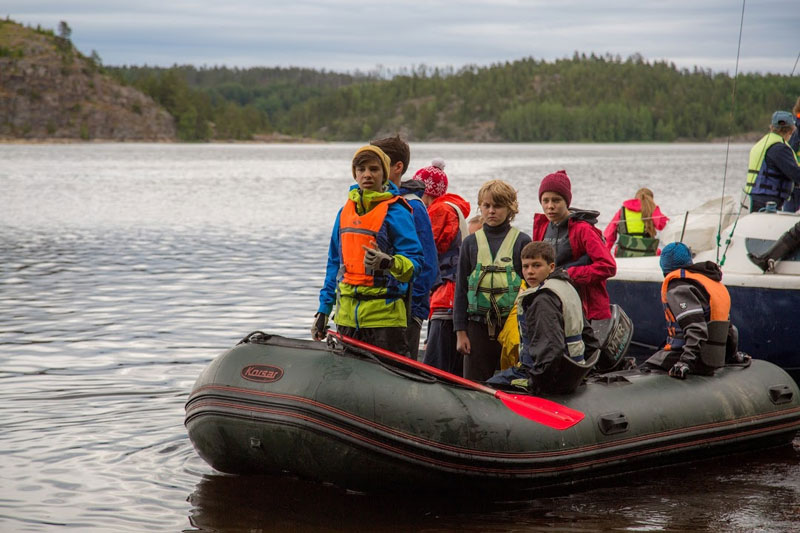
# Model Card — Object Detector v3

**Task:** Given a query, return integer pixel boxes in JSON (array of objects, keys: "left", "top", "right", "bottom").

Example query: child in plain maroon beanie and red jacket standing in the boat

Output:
[{"left": 533, "top": 170, "right": 617, "bottom": 320}]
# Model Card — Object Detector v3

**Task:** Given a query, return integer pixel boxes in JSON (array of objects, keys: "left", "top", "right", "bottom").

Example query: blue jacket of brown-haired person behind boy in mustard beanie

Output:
[{"left": 400, "top": 180, "right": 440, "bottom": 320}]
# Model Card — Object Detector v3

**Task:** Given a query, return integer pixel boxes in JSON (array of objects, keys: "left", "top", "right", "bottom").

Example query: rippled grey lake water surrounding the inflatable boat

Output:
[{"left": 0, "top": 144, "right": 800, "bottom": 532}]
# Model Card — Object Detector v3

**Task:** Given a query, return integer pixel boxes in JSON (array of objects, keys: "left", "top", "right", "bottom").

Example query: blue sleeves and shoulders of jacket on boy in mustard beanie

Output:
[{"left": 317, "top": 182, "right": 423, "bottom": 327}]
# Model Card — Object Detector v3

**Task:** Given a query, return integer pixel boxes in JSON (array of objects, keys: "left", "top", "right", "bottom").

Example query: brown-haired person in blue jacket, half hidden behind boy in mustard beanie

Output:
[{"left": 370, "top": 135, "right": 439, "bottom": 359}]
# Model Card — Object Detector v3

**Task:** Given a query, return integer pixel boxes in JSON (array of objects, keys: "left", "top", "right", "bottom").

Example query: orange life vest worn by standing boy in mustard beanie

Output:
[{"left": 339, "top": 196, "right": 411, "bottom": 287}]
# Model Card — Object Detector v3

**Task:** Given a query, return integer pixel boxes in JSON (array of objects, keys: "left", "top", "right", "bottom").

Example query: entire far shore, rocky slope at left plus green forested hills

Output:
[{"left": 0, "top": 19, "right": 800, "bottom": 142}]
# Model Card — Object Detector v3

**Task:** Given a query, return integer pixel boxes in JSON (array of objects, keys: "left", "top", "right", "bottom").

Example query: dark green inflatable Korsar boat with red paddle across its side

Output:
[{"left": 185, "top": 332, "right": 800, "bottom": 493}]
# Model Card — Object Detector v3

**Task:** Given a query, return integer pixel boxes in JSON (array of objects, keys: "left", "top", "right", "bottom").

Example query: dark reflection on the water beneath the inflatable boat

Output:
[{"left": 190, "top": 449, "right": 800, "bottom": 531}]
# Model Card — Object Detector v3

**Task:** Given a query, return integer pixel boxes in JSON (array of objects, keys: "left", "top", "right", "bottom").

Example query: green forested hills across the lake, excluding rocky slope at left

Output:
[{"left": 113, "top": 53, "right": 800, "bottom": 142}]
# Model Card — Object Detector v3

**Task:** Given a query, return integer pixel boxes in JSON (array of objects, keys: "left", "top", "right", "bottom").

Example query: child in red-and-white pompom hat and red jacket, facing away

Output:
[{"left": 413, "top": 158, "right": 470, "bottom": 376}]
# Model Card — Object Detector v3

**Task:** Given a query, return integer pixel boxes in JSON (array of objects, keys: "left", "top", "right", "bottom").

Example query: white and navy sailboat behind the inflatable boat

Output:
[{"left": 606, "top": 197, "right": 800, "bottom": 377}]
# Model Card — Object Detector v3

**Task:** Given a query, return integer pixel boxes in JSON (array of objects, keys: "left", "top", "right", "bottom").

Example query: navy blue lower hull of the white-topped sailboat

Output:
[{"left": 607, "top": 279, "right": 800, "bottom": 379}]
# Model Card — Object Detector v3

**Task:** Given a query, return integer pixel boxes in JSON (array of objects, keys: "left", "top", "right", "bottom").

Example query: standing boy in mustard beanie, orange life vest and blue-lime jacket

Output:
[{"left": 311, "top": 145, "right": 422, "bottom": 355}]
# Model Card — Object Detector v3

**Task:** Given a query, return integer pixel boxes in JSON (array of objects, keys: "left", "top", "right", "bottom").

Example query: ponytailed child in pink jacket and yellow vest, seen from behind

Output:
[{"left": 603, "top": 187, "right": 669, "bottom": 257}]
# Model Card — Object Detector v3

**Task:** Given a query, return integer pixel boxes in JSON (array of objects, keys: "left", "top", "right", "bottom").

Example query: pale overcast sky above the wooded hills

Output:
[{"left": 6, "top": 0, "right": 800, "bottom": 75}]
